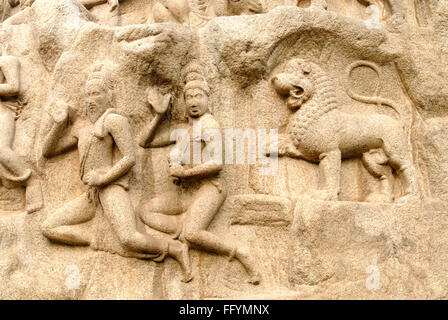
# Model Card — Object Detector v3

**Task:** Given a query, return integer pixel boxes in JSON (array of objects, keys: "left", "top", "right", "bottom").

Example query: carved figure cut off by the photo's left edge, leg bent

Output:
[{"left": 0, "top": 56, "right": 43, "bottom": 213}]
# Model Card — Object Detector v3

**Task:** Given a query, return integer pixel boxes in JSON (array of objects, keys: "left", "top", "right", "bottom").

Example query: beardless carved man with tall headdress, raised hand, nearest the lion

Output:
[{"left": 137, "top": 65, "right": 260, "bottom": 284}]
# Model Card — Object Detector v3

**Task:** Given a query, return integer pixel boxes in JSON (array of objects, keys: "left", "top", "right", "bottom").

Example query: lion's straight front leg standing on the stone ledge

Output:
[{"left": 311, "top": 149, "right": 341, "bottom": 201}]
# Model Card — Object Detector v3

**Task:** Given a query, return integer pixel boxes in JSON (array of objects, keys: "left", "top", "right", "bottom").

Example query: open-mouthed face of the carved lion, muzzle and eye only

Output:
[{"left": 272, "top": 72, "right": 314, "bottom": 111}]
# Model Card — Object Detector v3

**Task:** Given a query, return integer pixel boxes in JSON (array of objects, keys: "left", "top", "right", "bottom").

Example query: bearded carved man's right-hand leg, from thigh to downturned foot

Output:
[{"left": 100, "top": 185, "right": 191, "bottom": 281}]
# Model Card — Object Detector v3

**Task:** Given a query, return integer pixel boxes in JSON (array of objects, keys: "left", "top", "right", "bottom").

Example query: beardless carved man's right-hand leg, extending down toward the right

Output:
[{"left": 184, "top": 183, "right": 260, "bottom": 284}]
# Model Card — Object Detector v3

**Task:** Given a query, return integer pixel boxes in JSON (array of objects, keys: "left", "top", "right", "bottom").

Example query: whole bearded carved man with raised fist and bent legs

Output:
[{"left": 42, "top": 64, "right": 190, "bottom": 281}]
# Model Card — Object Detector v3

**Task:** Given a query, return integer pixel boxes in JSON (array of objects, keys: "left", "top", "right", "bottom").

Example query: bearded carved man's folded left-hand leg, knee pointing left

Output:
[{"left": 42, "top": 193, "right": 95, "bottom": 246}]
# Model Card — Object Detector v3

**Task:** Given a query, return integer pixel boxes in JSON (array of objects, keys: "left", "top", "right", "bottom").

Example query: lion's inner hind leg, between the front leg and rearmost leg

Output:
[{"left": 362, "top": 149, "right": 393, "bottom": 202}]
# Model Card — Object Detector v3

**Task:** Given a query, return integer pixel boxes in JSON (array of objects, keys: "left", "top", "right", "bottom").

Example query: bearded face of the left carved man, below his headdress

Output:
[{"left": 86, "top": 79, "right": 110, "bottom": 123}]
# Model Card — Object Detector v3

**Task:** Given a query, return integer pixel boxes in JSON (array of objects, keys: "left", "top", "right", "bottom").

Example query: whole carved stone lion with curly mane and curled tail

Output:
[{"left": 271, "top": 59, "right": 418, "bottom": 202}]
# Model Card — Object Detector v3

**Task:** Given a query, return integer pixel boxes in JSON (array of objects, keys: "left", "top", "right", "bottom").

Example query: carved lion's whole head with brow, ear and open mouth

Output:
[{"left": 271, "top": 59, "right": 315, "bottom": 111}]
